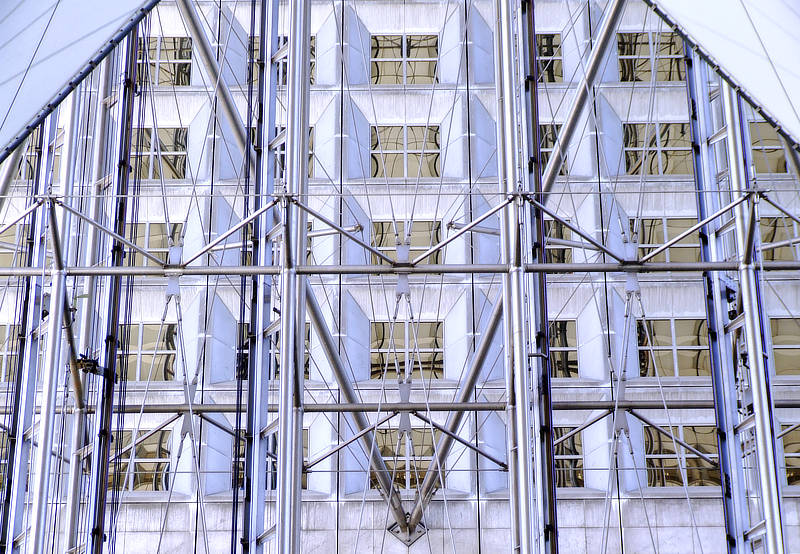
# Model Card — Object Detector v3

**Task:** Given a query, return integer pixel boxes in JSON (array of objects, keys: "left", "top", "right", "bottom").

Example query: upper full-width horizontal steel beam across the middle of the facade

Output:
[{"left": 0, "top": 261, "right": 800, "bottom": 277}]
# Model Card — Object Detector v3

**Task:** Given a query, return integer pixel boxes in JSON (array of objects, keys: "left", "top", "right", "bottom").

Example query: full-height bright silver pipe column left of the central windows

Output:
[{"left": 277, "top": 0, "right": 311, "bottom": 554}]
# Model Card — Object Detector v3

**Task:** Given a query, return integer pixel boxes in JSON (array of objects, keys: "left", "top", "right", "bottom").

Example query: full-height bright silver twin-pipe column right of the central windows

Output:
[{"left": 495, "top": 0, "right": 536, "bottom": 554}]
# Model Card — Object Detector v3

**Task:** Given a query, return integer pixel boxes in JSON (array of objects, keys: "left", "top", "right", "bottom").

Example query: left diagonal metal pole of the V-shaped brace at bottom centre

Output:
[{"left": 306, "top": 283, "right": 410, "bottom": 533}]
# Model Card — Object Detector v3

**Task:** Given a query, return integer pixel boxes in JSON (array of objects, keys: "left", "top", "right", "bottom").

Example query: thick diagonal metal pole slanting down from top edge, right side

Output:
[{"left": 542, "top": 0, "right": 625, "bottom": 195}]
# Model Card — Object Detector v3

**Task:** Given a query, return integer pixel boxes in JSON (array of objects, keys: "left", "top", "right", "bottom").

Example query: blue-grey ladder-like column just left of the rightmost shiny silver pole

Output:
[{"left": 684, "top": 49, "right": 747, "bottom": 554}]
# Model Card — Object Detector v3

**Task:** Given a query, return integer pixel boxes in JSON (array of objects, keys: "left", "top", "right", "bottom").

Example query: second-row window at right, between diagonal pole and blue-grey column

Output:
[{"left": 622, "top": 123, "right": 692, "bottom": 175}]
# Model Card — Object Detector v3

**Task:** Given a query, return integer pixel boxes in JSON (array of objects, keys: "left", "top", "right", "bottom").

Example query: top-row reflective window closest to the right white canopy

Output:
[{"left": 617, "top": 33, "right": 686, "bottom": 82}]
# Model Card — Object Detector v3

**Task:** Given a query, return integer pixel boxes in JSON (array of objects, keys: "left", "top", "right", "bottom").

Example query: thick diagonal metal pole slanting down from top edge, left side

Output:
[{"left": 176, "top": 0, "right": 256, "bottom": 175}]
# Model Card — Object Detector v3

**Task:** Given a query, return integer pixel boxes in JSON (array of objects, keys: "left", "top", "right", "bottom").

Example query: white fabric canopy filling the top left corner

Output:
[{"left": 0, "top": 0, "right": 152, "bottom": 159}]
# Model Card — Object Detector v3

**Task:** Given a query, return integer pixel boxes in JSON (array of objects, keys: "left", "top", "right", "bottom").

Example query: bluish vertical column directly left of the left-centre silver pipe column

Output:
[{"left": 242, "top": 0, "right": 280, "bottom": 553}]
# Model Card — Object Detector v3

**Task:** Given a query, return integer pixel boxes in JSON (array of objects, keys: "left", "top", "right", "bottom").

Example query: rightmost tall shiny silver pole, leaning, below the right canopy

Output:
[{"left": 722, "top": 81, "right": 784, "bottom": 554}]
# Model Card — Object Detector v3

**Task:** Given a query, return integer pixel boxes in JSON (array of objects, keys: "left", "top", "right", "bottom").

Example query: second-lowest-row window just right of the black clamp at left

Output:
[{"left": 117, "top": 322, "right": 178, "bottom": 381}]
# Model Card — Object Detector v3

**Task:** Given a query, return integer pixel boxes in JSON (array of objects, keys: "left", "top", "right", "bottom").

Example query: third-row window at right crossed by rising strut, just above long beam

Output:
[{"left": 631, "top": 217, "right": 700, "bottom": 262}]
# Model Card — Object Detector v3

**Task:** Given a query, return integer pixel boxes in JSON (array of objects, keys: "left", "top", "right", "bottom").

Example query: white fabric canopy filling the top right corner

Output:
[{"left": 647, "top": 0, "right": 800, "bottom": 144}]
